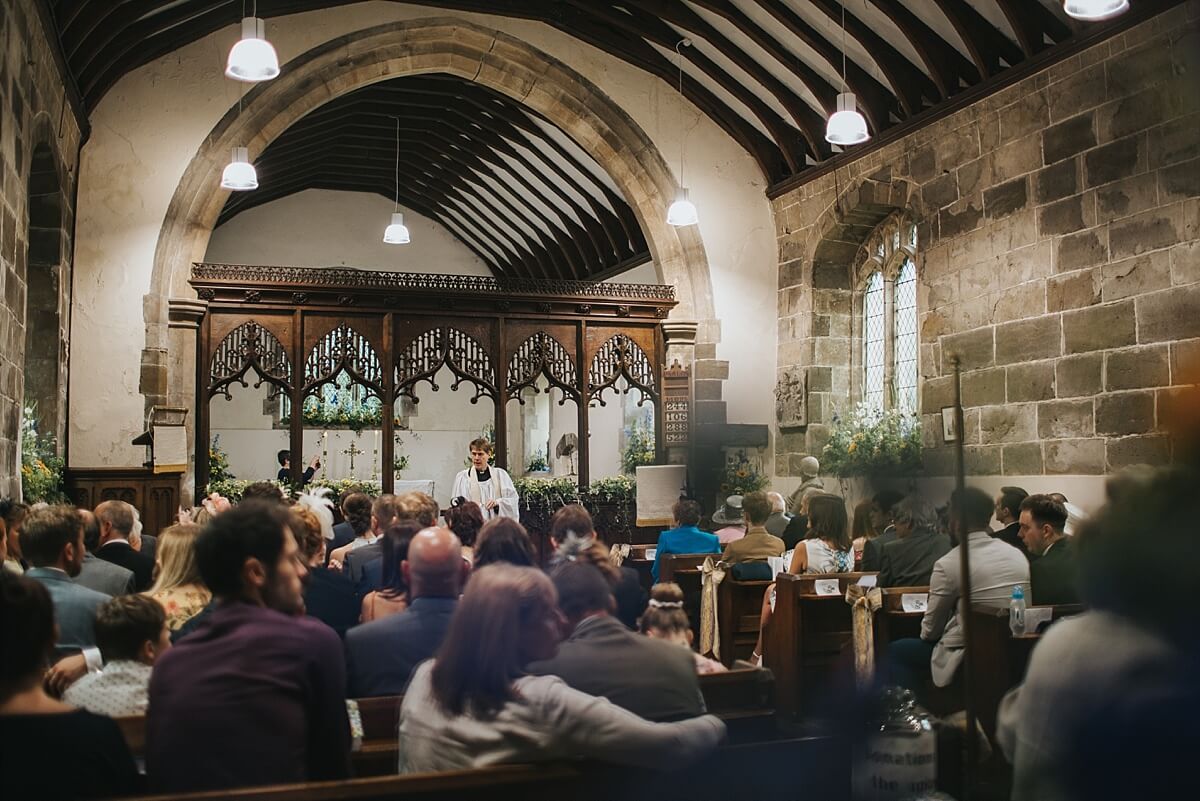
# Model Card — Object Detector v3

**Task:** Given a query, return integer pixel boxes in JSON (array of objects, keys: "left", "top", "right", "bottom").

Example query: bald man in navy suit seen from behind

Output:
[{"left": 346, "top": 529, "right": 470, "bottom": 698}]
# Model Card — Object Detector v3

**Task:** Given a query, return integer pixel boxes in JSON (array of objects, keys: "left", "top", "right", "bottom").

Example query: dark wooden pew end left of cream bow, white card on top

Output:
[{"left": 760, "top": 573, "right": 875, "bottom": 718}]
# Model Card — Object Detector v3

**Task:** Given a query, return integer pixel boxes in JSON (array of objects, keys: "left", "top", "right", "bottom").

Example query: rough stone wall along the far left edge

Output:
[{"left": 0, "top": 0, "right": 80, "bottom": 495}]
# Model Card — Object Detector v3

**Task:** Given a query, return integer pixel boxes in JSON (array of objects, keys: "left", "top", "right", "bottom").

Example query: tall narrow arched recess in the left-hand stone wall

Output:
[{"left": 20, "top": 114, "right": 71, "bottom": 452}]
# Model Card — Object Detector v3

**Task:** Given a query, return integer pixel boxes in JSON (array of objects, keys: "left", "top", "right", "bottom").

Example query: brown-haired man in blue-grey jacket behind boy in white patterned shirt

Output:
[{"left": 20, "top": 506, "right": 109, "bottom": 656}]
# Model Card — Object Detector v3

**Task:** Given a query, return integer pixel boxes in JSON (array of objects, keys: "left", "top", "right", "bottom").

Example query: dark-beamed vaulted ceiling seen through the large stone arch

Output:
[{"left": 218, "top": 74, "right": 650, "bottom": 279}]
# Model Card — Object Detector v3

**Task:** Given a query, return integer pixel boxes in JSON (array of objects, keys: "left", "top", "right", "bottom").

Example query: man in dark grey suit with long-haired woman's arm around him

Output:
[{"left": 528, "top": 562, "right": 704, "bottom": 722}]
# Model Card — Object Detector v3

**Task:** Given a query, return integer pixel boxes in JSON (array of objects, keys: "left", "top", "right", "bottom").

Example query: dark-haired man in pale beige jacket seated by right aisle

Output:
[{"left": 888, "top": 487, "right": 1030, "bottom": 691}]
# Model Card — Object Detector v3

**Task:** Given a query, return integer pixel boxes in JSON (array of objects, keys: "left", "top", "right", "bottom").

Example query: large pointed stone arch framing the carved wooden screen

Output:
[{"left": 142, "top": 17, "right": 715, "bottom": 419}]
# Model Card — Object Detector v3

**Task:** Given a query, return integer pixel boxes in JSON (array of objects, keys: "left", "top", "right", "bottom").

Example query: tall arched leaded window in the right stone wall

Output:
[{"left": 856, "top": 215, "right": 920, "bottom": 414}]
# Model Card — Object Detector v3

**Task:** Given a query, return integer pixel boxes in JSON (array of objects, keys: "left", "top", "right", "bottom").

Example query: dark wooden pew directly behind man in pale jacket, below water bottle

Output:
[{"left": 971, "top": 603, "right": 1084, "bottom": 740}]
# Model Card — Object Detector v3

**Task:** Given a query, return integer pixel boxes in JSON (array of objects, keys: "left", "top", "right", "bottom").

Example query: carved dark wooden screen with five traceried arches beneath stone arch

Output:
[{"left": 191, "top": 264, "right": 674, "bottom": 507}]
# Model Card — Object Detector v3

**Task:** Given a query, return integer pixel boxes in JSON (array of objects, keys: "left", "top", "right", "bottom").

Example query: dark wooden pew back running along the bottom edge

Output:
[{"left": 119, "top": 737, "right": 850, "bottom": 801}]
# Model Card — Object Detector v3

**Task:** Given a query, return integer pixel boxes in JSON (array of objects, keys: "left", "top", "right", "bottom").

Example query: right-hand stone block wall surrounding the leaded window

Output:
[{"left": 775, "top": 2, "right": 1200, "bottom": 476}]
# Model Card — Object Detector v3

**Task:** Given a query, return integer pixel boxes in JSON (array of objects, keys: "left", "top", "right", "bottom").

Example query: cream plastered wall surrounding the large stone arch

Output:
[{"left": 70, "top": 2, "right": 776, "bottom": 466}]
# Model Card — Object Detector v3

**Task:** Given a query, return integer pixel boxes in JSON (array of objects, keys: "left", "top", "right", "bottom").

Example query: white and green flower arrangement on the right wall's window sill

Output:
[{"left": 821, "top": 403, "right": 920, "bottom": 477}]
